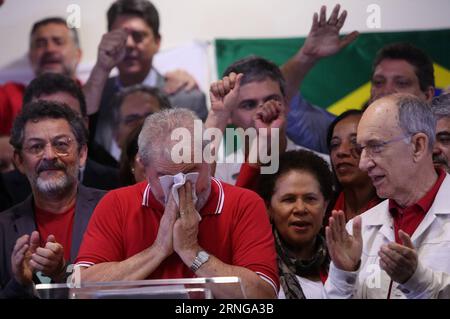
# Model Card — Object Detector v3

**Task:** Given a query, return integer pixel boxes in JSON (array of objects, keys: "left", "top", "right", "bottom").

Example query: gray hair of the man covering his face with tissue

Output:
[{"left": 138, "top": 108, "right": 205, "bottom": 166}]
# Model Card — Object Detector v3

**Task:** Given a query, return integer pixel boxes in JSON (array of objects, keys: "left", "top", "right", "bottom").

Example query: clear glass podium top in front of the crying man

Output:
[{"left": 36, "top": 277, "right": 245, "bottom": 299}]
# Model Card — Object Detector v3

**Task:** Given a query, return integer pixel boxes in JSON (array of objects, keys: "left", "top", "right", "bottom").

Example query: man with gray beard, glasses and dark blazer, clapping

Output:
[{"left": 0, "top": 100, "right": 104, "bottom": 298}]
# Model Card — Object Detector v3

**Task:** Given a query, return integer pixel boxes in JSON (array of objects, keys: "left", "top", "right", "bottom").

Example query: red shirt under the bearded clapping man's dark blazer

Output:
[{"left": 34, "top": 205, "right": 75, "bottom": 260}]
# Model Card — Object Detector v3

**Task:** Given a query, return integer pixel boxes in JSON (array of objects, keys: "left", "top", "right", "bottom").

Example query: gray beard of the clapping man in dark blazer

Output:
[{"left": 32, "top": 160, "right": 79, "bottom": 196}]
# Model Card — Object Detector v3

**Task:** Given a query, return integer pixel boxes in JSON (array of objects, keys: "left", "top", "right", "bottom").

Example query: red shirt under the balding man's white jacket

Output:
[{"left": 389, "top": 170, "right": 445, "bottom": 244}]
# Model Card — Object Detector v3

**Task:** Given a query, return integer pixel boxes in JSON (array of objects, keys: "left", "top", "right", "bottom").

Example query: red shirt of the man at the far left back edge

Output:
[{"left": 0, "top": 82, "right": 25, "bottom": 135}]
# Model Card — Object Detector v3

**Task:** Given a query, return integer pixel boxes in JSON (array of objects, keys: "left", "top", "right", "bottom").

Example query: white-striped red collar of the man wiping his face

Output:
[{"left": 139, "top": 177, "right": 225, "bottom": 216}]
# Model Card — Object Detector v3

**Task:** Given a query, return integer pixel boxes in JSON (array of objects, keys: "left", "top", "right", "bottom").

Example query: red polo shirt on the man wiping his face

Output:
[{"left": 76, "top": 178, "right": 279, "bottom": 292}]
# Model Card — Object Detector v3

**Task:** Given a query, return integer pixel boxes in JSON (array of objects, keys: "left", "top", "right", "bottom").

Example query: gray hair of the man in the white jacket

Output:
[{"left": 394, "top": 94, "right": 436, "bottom": 152}]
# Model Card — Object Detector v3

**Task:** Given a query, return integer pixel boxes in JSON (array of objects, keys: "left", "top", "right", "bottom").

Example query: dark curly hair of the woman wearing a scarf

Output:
[{"left": 257, "top": 150, "right": 333, "bottom": 204}]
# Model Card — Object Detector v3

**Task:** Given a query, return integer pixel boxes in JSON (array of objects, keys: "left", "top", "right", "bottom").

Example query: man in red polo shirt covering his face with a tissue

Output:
[{"left": 77, "top": 109, "right": 279, "bottom": 298}]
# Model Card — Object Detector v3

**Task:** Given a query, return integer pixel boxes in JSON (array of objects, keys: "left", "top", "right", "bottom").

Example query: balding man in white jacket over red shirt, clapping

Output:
[{"left": 325, "top": 93, "right": 450, "bottom": 299}]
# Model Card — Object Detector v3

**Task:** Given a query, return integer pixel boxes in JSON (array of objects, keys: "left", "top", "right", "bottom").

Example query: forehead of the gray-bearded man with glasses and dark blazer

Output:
[{"left": 24, "top": 118, "right": 73, "bottom": 141}]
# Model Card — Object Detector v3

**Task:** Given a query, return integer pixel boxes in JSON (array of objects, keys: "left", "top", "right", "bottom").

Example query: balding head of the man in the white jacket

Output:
[{"left": 357, "top": 93, "right": 436, "bottom": 205}]
